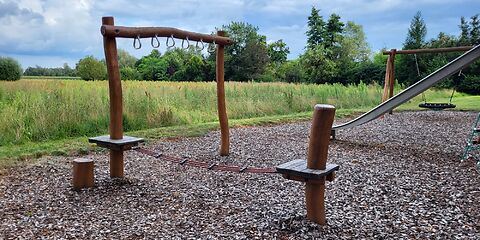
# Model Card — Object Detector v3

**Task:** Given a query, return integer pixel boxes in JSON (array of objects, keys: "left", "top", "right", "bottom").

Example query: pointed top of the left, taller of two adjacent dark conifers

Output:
[{"left": 306, "top": 7, "right": 325, "bottom": 48}]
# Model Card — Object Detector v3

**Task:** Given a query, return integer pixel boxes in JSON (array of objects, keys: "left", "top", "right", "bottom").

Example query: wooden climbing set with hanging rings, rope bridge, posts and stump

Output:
[{"left": 77, "top": 17, "right": 339, "bottom": 224}]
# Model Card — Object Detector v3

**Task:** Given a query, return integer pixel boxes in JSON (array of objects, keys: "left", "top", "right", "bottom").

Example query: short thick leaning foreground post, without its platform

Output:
[{"left": 305, "top": 104, "right": 335, "bottom": 225}]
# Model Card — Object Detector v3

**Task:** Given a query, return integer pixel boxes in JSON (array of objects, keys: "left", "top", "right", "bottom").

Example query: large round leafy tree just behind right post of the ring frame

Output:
[{"left": 221, "top": 22, "right": 268, "bottom": 81}]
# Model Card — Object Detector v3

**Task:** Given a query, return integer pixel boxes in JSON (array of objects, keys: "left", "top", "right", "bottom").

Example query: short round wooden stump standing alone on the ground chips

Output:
[{"left": 72, "top": 158, "right": 95, "bottom": 190}]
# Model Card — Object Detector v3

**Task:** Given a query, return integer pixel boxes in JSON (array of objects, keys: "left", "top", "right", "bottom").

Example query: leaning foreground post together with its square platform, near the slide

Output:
[{"left": 277, "top": 104, "right": 339, "bottom": 225}]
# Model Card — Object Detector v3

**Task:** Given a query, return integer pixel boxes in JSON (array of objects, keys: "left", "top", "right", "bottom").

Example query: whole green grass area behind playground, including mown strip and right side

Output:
[{"left": 0, "top": 79, "right": 480, "bottom": 168}]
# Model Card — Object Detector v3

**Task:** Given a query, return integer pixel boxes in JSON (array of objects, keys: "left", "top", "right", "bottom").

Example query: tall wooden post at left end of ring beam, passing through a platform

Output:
[{"left": 102, "top": 17, "right": 123, "bottom": 177}]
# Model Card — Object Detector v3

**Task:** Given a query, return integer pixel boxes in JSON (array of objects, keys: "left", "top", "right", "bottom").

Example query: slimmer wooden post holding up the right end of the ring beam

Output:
[{"left": 216, "top": 31, "right": 230, "bottom": 156}]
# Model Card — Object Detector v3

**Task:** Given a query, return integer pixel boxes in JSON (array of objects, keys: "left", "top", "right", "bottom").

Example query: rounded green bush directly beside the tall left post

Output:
[{"left": 76, "top": 56, "right": 107, "bottom": 81}]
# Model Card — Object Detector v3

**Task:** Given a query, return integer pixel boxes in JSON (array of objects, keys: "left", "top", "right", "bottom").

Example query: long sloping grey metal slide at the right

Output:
[{"left": 332, "top": 45, "right": 480, "bottom": 130}]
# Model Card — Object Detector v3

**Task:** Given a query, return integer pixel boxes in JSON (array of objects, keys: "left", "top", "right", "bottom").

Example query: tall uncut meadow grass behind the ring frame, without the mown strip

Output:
[{"left": 0, "top": 80, "right": 450, "bottom": 146}]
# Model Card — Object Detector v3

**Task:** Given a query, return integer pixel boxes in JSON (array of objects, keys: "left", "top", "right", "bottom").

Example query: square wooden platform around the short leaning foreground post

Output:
[{"left": 277, "top": 159, "right": 340, "bottom": 180}]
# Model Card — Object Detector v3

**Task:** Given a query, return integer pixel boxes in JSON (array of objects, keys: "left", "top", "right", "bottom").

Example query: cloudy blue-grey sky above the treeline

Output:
[{"left": 0, "top": 0, "right": 480, "bottom": 69}]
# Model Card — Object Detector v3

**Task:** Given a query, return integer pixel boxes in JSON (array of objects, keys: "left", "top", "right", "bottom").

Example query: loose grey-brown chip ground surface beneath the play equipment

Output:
[{"left": 0, "top": 111, "right": 480, "bottom": 239}]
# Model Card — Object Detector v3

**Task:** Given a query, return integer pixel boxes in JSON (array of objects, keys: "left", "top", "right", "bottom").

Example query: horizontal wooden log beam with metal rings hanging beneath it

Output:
[{"left": 100, "top": 25, "right": 233, "bottom": 45}]
